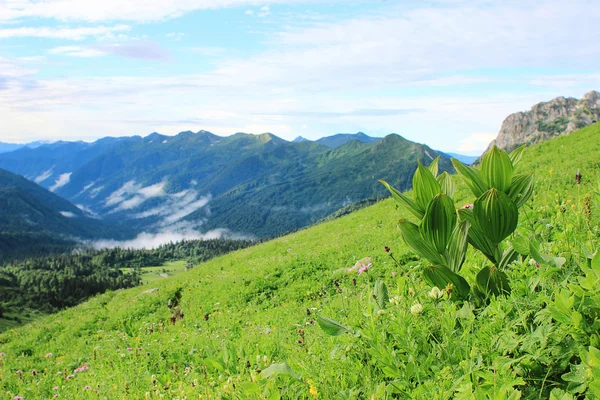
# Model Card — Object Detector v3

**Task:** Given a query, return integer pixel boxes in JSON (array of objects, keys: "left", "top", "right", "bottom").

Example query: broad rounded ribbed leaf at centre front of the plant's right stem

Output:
[{"left": 473, "top": 188, "right": 519, "bottom": 244}]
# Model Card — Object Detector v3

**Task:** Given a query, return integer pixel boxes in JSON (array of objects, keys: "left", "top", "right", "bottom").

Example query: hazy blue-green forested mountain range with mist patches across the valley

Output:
[{"left": 0, "top": 131, "right": 452, "bottom": 247}]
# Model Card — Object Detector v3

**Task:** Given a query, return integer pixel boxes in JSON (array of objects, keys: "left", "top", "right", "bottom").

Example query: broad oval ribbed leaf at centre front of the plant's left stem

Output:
[{"left": 420, "top": 194, "right": 457, "bottom": 253}]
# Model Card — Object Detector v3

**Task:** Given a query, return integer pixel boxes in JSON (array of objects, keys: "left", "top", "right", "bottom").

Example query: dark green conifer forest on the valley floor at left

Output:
[{"left": 0, "top": 239, "right": 255, "bottom": 312}]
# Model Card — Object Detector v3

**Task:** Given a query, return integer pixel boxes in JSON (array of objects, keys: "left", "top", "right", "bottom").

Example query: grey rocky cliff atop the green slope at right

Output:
[{"left": 486, "top": 91, "right": 600, "bottom": 151}]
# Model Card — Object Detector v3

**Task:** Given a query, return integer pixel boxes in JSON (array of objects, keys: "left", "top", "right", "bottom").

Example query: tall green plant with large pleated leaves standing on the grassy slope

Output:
[{"left": 381, "top": 146, "right": 533, "bottom": 300}]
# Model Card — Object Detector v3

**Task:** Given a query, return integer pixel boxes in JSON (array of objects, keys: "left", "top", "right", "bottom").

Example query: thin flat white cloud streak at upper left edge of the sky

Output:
[{"left": 0, "top": 24, "right": 131, "bottom": 40}]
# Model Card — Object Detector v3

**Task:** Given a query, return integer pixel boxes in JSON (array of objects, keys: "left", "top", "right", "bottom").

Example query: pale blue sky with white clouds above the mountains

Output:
[{"left": 0, "top": 0, "right": 600, "bottom": 155}]
